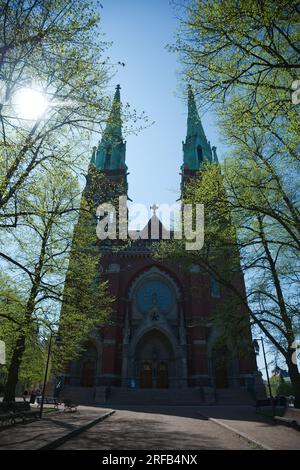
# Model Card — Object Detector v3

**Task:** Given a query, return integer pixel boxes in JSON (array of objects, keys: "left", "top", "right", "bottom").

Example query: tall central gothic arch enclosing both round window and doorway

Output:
[{"left": 122, "top": 266, "right": 187, "bottom": 388}]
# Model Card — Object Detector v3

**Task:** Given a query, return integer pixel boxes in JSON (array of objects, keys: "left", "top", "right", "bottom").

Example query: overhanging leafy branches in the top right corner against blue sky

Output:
[{"left": 172, "top": 0, "right": 300, "bottom": 120}]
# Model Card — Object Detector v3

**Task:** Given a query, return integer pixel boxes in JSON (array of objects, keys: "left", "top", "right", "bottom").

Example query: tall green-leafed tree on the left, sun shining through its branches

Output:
[{"left": 0, "top": 0, "right": 145, "bottom": 400}]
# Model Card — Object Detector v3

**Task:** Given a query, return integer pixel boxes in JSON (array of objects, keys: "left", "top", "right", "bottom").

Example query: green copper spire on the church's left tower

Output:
[{"left": 91, "top": 85, "right": 127, "bottom": 171}]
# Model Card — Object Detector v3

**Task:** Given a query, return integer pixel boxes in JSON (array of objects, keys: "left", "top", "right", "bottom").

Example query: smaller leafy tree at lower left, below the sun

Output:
[{"left": 1, "top": 165, "right": 109, "bottom": 401}]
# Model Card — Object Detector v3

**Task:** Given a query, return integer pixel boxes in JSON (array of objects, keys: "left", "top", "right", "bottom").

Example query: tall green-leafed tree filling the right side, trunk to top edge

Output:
[{"left": 173, "top": 0, "right": 300, "bottom": 407}]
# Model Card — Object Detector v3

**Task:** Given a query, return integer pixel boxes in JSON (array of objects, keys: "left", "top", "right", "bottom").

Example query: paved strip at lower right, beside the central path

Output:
[{"left": 198, "top": 406, "right": 300, "bottom": 450}]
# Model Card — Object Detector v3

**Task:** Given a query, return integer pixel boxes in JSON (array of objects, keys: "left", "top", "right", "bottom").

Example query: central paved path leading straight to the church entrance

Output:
[{"left": 58, "top": 406, "right": 255, "bottom": 450}]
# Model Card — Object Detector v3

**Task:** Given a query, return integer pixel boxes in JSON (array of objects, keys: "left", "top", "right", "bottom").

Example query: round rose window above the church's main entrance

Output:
[{"left": 136, "top": 280, "right": 174, "bottom": 312}]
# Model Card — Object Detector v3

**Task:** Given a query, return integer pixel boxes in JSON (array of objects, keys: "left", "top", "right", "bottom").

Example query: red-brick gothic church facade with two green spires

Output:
[{"left": 64, "top": 86, "right": 256, "bottom": 398}]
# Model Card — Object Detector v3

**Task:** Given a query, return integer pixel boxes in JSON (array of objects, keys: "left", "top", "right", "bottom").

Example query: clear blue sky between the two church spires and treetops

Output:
[{"left": 100, "top": 0, "right": 282, "bottom": 377}]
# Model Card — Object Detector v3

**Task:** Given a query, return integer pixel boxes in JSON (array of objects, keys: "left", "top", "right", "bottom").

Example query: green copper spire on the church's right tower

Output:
[{"left": 183, "top": 85, "right": 214, "bottom": 171}]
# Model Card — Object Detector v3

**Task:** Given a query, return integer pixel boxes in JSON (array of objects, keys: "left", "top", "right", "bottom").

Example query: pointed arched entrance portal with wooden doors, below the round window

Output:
[{"left": 135, "top": 329, "right": 175, "bottom": 388}]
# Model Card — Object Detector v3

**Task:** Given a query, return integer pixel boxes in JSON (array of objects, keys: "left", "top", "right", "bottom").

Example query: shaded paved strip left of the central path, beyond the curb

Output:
[{"left": 0, "top": 406, "right": 111, "bottom": 450}]
